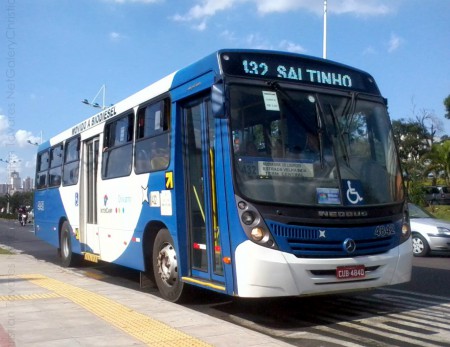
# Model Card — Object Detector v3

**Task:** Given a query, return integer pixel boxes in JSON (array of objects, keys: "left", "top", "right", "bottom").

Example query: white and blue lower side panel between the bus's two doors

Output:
[{"left": 99, "top": 169, "right": 176, "bottom": 271}]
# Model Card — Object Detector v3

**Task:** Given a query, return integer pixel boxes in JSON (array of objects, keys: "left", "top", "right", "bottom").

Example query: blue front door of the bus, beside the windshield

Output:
[{"left": 183, "top": 98, "right": 224, "bottom": 290}]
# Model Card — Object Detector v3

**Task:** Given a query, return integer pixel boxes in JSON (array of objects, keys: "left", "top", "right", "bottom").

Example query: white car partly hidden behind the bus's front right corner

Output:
[{"left": 408, "top": 203, "right": 450, "bottom": 257}]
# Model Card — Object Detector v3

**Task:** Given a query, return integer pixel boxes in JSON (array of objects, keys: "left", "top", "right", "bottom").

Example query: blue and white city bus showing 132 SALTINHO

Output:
[{"left": 34, "top": 49, "right": 412, "bottom": 302}]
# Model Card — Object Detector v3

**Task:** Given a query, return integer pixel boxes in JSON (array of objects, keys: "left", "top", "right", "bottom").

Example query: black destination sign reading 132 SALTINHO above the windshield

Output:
[{"left": 221, "top": 52, "right": 379, "bottom": 94}]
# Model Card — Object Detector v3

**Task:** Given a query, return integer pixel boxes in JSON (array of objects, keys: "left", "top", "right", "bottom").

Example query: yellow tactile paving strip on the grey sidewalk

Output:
[{"left": 9, "top": 274, "right": 210, "bottom": 347}]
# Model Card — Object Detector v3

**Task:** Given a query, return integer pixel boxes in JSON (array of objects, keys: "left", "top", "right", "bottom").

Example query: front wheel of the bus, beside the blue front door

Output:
[{"left": 152, "top": 229, "right": 185, "bottom": 302}]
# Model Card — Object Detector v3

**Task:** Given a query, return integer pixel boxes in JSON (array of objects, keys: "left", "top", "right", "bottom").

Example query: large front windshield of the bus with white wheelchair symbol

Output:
[{"left": 229, "top": 83, "right": 404, "bottom": 206}]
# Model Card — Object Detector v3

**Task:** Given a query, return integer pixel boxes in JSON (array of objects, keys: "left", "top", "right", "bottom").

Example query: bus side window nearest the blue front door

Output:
[{"left": 134, "top": 99, "right": 170, "bottom": 174}]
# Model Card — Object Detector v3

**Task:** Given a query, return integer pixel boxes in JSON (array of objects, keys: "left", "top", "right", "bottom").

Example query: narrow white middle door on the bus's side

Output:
[{"left": 80, "top": 136, "right": 100, "bottom": 254}]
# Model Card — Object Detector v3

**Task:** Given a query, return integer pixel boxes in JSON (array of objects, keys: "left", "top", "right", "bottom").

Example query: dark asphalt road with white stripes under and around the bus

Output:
[{"left": 0, "top": 220, "right": 450, "bottom": 347}]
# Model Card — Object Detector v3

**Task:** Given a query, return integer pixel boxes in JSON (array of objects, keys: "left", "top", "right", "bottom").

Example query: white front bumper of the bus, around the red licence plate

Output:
[{"left": 235, "top": 241, "right": 412, "bottom": 298}]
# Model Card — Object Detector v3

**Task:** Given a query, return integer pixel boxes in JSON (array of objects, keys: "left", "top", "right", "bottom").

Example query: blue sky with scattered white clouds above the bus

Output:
[{"left": 0, "top": 0, "right": 450, "bottom": 183}]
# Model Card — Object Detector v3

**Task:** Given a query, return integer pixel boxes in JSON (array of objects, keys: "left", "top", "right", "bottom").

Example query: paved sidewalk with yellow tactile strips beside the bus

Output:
[{"left": 0, "top": 245, "right": 291, "bottom": 347}]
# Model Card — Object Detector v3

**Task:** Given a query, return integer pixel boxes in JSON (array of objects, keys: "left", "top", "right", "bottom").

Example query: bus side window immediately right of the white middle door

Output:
[{"left": 102, "top": 113, "right": 133, "bottom": 179}]
